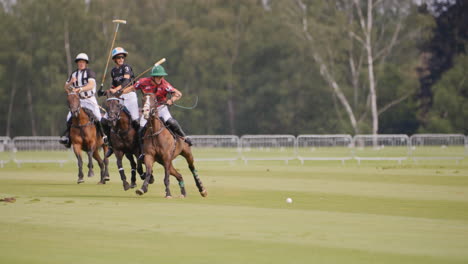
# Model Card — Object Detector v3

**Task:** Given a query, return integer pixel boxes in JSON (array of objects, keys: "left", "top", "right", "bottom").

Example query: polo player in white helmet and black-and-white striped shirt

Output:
[{"left": 60, "top": 53, "right": 107, "bottom": 148}]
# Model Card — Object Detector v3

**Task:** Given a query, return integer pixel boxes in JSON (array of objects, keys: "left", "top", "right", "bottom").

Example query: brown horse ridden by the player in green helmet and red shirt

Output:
[{"left": 136, "top": 94, "right": 208, "bottom": 198}]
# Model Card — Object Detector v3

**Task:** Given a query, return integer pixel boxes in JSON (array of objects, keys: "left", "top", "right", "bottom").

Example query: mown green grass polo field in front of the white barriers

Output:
[{"left": 0, "top": 157, "right": 468, "bottom": 264}]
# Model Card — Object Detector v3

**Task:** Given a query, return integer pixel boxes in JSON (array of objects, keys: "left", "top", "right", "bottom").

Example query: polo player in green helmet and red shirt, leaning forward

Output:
[{"left": 124, "top": 65, "right": 192, "bottom": 158}]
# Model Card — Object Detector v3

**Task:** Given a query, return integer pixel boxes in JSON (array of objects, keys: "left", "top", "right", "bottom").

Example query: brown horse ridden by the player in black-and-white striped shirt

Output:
[{"left": 67, "top": 92, "right": 109, "bottom": 184}]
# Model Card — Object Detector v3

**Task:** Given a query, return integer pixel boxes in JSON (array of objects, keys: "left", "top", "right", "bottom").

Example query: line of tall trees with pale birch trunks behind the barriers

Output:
[{"left": 0, "top": 0, "right": 468, "bottom": 137}]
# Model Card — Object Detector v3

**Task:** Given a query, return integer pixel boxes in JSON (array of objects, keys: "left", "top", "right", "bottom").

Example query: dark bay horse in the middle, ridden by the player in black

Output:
[{"left": 106, "top": 92, "right": 144, "bottom": 191}]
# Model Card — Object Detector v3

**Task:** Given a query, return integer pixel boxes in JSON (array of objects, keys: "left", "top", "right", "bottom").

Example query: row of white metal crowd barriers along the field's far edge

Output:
[{"left": 0, "top": 134, "right": 468, "bottom": 167}]
